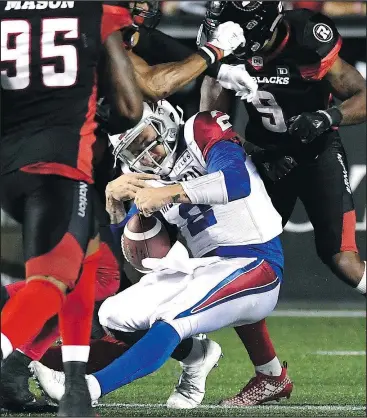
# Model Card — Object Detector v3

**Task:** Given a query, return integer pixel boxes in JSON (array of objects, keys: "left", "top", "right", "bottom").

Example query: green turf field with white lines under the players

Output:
[{"left": 2, "top": 317, "right": 366, "bottom": 417}]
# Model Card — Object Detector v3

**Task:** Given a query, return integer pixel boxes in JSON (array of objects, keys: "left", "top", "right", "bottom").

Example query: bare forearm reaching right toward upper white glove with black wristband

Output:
[{"left": 138, "top": 54, "right": 208, "bottom": 101}]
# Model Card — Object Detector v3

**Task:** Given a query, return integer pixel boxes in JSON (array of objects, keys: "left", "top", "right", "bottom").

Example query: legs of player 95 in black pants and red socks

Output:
[{"left": 1, "top": 171, "right": 98, "bottom": 416}]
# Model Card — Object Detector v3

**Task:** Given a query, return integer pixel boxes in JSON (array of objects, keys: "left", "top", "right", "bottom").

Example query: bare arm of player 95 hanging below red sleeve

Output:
[{"left": 104, "top": 31, "right": 143, "bottom": 125}]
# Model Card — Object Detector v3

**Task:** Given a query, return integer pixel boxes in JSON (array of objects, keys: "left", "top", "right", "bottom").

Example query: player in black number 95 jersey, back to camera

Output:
[{"left": 0, "top": 2, "right": 143, "bottom": 416}]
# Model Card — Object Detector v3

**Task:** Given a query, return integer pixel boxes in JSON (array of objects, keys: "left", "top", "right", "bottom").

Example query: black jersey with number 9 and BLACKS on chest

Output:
[{"left": 242, "top": 9, "right": 342, "bottom": 153}]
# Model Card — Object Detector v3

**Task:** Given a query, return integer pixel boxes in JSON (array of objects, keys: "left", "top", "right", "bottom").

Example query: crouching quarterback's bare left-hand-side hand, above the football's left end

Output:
[{"left": 106, "top": 173, "right": 159, "bottom": 224}]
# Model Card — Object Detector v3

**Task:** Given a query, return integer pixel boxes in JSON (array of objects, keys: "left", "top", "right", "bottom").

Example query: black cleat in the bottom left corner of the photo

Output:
[{"left": 0, "top": 351, "right": 56, "bottom": 412}]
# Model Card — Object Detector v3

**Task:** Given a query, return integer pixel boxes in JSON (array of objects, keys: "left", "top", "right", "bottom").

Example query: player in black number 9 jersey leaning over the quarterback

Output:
[{"left": 201, "top": 1, "right": 367, "bottom": 406}]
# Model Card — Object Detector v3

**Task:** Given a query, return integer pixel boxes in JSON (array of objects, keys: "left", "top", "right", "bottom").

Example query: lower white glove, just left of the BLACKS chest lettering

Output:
[{"left": 217, "top": 64, "right": 258, "bottom": 103}]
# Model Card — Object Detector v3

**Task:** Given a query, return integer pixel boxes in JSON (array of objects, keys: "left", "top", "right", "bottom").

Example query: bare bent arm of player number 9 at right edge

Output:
[{"left": 325, "top": 58, "right": 367, "bottom": 125}]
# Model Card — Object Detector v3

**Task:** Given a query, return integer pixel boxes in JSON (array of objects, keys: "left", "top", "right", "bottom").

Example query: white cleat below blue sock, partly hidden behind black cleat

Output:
[{"left": 30, "top": 361, "right": 98, "bottom": 406}]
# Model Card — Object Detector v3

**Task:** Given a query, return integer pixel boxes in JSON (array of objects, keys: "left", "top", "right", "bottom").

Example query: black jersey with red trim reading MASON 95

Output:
[{"left": 0, "top": 1, "right": 131, "bottom": 181}]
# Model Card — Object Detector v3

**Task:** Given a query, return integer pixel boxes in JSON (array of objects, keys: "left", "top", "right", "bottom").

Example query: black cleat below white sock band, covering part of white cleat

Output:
[{"left": 57, "top": 361, "right": 96, "bottom": 417}]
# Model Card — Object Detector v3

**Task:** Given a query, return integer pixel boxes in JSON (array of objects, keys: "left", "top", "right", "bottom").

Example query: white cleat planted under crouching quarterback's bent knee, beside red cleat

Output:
[{"left": 166, "top": 335, "right": 222, "bottom": 409}]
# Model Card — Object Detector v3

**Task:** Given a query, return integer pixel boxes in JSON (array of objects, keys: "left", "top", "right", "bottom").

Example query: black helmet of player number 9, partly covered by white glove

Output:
[{"left": 201, "top": 1, "right": 283, "bottom": 59}]
